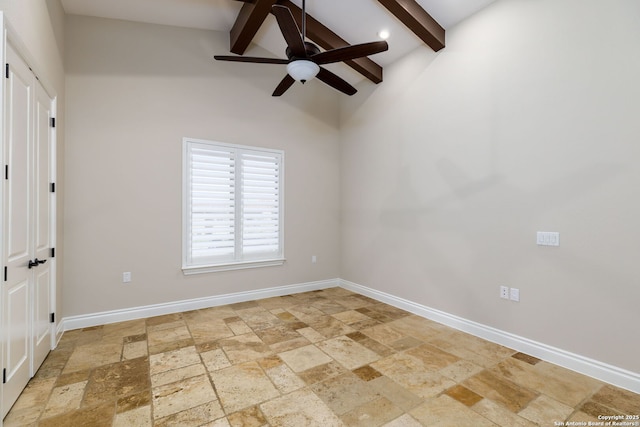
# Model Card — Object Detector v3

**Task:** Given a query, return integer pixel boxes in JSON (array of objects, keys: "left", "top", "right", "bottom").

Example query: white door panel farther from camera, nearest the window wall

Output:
[{"left": 31, "top": 81, "right": 53, "bottom": 375}]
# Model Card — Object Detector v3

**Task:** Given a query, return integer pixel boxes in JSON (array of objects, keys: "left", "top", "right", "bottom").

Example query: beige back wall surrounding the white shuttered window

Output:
[{"left": 64, "top": 16, "right": 339, "bottom": 316}]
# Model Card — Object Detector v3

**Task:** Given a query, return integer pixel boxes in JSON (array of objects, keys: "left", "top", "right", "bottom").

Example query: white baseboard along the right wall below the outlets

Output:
[{"left": 339, "top": 279, "right": 640, "bottom": 393}]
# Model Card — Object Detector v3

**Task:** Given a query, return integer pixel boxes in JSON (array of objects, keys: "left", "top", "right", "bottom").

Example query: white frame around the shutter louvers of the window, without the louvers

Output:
[{"left": 182, "top": 137, "right": 285, "bottom": 275}]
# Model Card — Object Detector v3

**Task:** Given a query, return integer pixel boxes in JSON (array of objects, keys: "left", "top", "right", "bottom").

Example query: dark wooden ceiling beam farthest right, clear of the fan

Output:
[{"left": 378, "top": 0, "right": 445, "bottom": 52}]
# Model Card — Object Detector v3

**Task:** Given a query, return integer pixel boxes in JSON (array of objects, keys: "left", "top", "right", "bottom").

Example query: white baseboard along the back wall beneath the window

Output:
[{"left": 61, "top": 279, "right": 339, "bottom": 331}]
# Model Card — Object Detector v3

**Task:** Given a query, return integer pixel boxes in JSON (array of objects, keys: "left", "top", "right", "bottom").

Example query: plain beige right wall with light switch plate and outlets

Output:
[{"left": 341, "top": 0, "right": 640, "bottom": 372}]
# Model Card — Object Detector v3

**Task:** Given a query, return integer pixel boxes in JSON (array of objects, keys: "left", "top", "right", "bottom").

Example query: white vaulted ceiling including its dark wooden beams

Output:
[{"left": 62, "top": 0, "right": 494, "bottom": 83}]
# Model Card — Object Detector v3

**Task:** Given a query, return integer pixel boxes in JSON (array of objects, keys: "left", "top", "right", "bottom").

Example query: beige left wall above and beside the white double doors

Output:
[{"left": 0, "top": 0, "right": 65, "bottom": 319}]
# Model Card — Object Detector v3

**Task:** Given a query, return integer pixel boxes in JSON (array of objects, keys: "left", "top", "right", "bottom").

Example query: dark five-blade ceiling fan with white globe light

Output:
[{"left": 214, "top": 0, "right": 389, "bottom": 96}]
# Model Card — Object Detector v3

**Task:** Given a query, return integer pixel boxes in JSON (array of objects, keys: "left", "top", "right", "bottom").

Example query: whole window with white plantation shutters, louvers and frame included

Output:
[{"left": 182, "top": 138, "right": 284, "bottom": 274}]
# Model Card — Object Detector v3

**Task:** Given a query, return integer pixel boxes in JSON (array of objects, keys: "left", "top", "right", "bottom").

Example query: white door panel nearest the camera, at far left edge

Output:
[{"left": 2, "top": 45, "right": 34, "bottom": 417}]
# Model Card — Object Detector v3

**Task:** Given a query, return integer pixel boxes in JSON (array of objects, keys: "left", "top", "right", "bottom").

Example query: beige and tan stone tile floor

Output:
[{"left": 4, "top": 288, "right": 640, "bottom": 427}]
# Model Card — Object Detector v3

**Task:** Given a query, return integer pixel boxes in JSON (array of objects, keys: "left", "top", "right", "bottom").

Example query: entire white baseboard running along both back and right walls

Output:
[{"left": 56, "top": 279, "right": 640, "bottom": 393}]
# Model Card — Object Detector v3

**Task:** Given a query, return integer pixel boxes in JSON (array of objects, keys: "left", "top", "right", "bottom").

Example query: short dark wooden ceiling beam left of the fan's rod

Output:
[{"left": 229, "top": 0, "right": 277, "bottom": 55}]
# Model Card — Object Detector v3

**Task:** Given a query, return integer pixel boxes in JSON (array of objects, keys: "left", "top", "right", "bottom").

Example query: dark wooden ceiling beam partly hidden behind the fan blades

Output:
[{"left": 278, "top": 0, "right": 382, "bottom": 83}]
